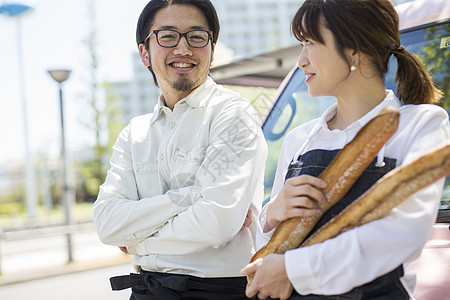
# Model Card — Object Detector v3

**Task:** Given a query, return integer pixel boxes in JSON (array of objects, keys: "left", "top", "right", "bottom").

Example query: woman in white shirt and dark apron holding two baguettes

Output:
[{"left": 242, "top": 0, "right": 450, "bottom": 299}]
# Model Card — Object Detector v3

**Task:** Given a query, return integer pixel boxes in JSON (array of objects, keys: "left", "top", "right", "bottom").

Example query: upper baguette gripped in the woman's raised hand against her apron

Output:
[{"left": 248, "top": 107, "right": 399, "bottom": 264}]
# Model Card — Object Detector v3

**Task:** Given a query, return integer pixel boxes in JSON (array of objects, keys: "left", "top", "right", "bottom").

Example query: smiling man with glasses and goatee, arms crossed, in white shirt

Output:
[{"left": 94, "top": 0, "right": 267, "bottom": 300}]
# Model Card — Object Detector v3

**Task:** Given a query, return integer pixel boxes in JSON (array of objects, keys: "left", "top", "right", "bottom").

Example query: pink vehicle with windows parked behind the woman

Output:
[{"left": 263, "top": 0, "right": 450, "bottom": 300}]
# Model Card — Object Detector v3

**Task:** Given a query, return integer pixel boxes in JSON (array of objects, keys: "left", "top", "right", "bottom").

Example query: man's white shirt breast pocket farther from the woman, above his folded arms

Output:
[{"left": 133, "top": 161, "right": 159, "bottom": 199}]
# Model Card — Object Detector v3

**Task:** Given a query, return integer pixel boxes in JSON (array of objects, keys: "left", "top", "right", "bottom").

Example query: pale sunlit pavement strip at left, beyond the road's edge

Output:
[{"left": 0, "top": 224, "right": 132, "bottom": 287}]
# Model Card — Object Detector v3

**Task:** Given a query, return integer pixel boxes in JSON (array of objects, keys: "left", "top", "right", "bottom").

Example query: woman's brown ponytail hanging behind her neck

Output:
[{"left": 390, "top": 46, "right": 442, "bottom": 104}]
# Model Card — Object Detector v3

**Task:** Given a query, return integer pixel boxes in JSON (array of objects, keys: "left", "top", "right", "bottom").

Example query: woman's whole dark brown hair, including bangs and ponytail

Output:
[{"left": 292, "top": 0, "right": 442, "bottom": 104}]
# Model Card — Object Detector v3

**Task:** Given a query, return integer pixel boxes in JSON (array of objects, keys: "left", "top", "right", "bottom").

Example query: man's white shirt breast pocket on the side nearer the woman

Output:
[{"left": 170, "top": 148, "right": 206, "bottom": 188}]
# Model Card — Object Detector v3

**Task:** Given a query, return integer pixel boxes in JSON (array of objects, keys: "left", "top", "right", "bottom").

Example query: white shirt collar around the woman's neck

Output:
[{"left": 320, "top": 90, "right": 402, "bottom": 129}]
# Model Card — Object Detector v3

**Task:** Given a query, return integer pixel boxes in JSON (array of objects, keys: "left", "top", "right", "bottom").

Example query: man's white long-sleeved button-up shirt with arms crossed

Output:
[{"left": 94, "top": 78, "right": 267, "bottom": 277}]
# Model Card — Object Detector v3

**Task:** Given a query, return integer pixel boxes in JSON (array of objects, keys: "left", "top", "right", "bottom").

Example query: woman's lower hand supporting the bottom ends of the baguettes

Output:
[{"left": 241, "top": 254, "right": 293, "bottom": 299}]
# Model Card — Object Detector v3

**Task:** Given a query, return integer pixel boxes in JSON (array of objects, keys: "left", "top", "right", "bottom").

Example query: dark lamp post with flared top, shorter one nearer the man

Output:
[{"left": 48, "top": 70, "right": 73, "bottom": 263}]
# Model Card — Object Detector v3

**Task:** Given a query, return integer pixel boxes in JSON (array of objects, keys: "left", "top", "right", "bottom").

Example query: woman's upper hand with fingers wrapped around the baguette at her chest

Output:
[{"left": 264, "top": 175, "right": 326, "bottom": 232}]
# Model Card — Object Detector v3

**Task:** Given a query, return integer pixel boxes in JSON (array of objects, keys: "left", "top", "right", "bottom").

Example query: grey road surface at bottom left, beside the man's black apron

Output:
[{"left": 0, "top": 264, "right": 133, "bottom": 300}]
